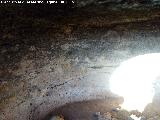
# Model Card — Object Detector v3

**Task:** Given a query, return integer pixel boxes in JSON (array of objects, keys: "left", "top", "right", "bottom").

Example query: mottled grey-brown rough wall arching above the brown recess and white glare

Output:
[{"left": 0, "top": 3, "right": 160, "bottom": 120}]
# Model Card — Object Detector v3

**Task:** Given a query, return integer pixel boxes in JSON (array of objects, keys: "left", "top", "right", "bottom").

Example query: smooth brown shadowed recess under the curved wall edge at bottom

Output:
[{"left": 44, "top": 97, "right": 123, "bottom": 120}]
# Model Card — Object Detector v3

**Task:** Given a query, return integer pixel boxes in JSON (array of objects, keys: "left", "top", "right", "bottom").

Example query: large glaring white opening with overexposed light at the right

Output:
[{"left": 110, "top": 53, "right": 160, "bottom": 112}]
